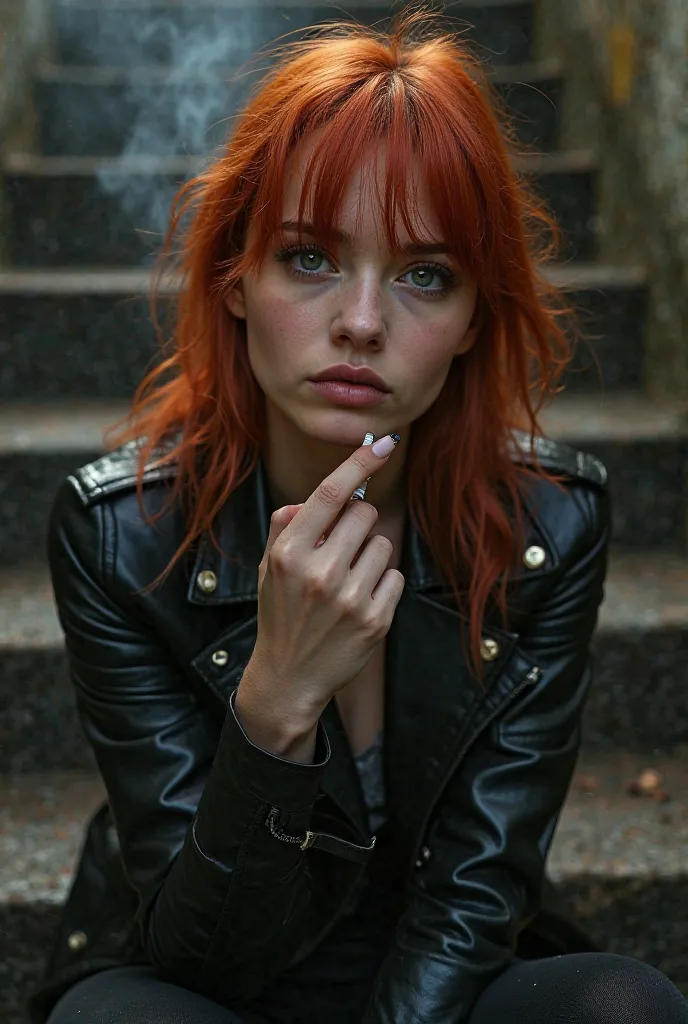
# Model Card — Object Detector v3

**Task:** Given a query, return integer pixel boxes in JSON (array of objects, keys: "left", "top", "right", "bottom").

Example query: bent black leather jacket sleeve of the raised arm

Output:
[{"left": 48, "top": 482, "right": 330, "bottom": 1000}]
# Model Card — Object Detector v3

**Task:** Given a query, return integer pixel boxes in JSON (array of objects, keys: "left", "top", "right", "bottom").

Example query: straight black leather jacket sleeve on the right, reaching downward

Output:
[{"left": 363, "top": 485, "right": 609, "bottom": 1024}]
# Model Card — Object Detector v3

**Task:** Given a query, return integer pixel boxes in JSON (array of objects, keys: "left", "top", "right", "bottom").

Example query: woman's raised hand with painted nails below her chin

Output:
[{"left": 245, "top": 432, "right": 405, "bottom": 722}]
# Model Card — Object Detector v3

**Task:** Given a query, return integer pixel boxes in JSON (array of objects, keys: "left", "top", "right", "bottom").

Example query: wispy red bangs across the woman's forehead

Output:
[{"left": 237, "top": 59, "right": 497, "bottom": 287}]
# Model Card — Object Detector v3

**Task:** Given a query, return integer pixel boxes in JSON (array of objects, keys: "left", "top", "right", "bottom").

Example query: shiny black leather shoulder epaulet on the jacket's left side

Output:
[{"left": 69, "top": 438, "right": 177, "bottom": 505}]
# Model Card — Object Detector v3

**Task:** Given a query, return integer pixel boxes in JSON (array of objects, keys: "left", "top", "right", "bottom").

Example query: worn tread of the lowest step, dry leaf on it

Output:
[{"left": 0, "top": 751, "right": 688, "bottom": 897}]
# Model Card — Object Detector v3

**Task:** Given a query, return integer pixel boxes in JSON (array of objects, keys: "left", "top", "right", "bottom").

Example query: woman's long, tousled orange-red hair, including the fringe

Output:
[{"left": 105, "top": 8, "right": 570, "bottom": 676}]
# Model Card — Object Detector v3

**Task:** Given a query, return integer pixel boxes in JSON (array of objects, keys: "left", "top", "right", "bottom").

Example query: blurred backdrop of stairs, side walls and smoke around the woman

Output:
[{"left": 0, "top": 0, "right": 688, "bottom": 1024}]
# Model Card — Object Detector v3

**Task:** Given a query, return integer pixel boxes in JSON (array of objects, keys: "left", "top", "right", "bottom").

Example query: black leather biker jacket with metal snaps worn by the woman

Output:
[{"left": 32, "top": 435, "right": 610, "bottom": 1024}]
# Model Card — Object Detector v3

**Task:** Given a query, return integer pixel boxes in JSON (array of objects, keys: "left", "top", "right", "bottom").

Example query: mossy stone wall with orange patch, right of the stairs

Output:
[{"left": 540, "top": 0, "right": 688, "bottom": 399}]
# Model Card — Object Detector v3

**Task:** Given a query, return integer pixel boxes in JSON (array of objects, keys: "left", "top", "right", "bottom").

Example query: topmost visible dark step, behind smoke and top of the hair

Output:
[{"left": 53, "top": 0, "right": 533, "bottom": 70}]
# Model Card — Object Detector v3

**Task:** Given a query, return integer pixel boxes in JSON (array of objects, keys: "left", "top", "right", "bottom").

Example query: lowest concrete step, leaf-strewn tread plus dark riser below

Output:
[{"left": 0, "top": 753, "right": 688, "bottom": 1024}]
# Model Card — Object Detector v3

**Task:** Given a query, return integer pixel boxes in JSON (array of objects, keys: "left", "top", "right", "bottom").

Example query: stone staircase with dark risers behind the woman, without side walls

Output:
[{"left": 0, "top": 0, "right": 688, "bottom": 1024}]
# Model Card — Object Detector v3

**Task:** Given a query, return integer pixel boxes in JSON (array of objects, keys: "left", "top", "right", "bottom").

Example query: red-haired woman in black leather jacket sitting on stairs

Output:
[{"left": 33, "top": 12, "right": 688, "bottom": 1024}]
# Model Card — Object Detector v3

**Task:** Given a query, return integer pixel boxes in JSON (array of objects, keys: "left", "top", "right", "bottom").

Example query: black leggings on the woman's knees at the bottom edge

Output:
[{"left": 48, "top": 953, "right": 688, "bottom": 1024}]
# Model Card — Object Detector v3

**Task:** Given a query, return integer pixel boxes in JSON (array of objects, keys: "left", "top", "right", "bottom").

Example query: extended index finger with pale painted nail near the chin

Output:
[{"left": 298, "top": 434, "right": 401, "bottom": 547}]
